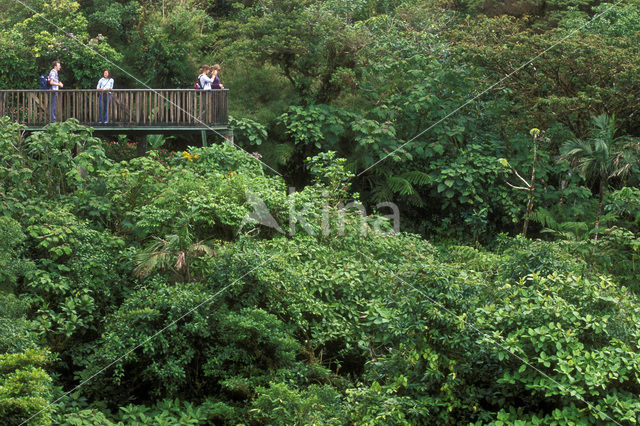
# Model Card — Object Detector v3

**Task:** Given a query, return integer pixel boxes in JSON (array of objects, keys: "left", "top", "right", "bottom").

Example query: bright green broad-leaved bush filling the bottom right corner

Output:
[{"left": 477, "top": 275, "right": 640, "bottom": 423}]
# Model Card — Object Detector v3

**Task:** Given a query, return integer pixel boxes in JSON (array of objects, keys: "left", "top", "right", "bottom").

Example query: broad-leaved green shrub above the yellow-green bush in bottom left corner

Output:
[{"left": 20, "top": 206, "right": 126, "bottom": 365}]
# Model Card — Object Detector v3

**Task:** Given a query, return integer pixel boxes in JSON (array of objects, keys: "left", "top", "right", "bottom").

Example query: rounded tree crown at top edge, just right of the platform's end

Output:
[{"left": 219, "top": 0, "right": 366, "bottom": 103}]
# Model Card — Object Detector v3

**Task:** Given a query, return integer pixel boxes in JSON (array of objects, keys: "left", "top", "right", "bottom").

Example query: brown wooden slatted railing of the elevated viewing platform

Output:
[{"left": 0, "top": 89, "right": 229, "bottom": 127}]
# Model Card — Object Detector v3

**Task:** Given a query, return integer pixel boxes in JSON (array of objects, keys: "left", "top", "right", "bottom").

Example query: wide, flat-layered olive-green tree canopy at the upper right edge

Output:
[{"left": 450, "top": 16, "right": 640, "bottom": 137}]
